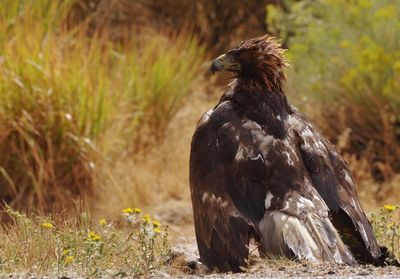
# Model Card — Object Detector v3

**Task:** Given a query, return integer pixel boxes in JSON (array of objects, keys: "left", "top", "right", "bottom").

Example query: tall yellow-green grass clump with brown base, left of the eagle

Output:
[{"left": 0, "top": 0, "right": 203, "bottom": 212}]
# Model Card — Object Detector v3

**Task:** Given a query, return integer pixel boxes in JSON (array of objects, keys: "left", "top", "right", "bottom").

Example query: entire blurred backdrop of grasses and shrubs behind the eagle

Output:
[{"left": 0, "top": 0, "right": 400, "bottom": 219}]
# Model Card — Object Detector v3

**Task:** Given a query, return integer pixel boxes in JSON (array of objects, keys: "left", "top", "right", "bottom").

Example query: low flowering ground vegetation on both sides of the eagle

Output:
[{"left": 0, "top": 201, "right": 400, "bottom": 278}]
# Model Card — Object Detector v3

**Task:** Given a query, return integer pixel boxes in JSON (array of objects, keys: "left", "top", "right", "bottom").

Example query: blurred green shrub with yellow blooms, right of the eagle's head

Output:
[{"left": 267, "top": 0, "right": 400, "bottom": 181}]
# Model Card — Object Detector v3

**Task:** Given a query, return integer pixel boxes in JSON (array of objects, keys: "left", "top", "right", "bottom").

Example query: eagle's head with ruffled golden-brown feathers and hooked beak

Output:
[{"left": 211, "top": 35, "right": 288, "bottom": 90}]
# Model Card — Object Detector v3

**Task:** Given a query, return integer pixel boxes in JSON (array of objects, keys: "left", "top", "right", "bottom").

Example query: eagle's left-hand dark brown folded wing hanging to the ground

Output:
[{"left": 190, "top": 108, "right": 252, "bottom": 272}]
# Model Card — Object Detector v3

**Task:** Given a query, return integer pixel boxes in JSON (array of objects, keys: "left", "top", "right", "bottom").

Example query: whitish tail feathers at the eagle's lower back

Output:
[{"left": 260, "top": 211, "right": 356, "bottom": 264}]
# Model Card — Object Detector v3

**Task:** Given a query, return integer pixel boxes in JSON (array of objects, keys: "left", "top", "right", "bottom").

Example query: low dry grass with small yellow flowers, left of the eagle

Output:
[{"left": 0, "top": 206, "right": 171, "bottom": 278}]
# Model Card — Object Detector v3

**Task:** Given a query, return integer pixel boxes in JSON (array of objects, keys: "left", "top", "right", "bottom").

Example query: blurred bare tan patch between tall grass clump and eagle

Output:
[{"left": 96, "top": 75, "right": 217, "bottom": 220}]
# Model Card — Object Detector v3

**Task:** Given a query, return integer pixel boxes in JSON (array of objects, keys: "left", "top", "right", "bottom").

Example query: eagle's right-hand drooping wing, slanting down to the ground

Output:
[{"left": 291, "top": 109, "right": 381, "bottom": 262}]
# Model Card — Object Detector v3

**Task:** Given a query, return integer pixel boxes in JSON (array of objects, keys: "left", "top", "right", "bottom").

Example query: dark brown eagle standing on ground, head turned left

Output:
[{"left": 190, "top": 35, "right": 386, "bottom": 272}]
